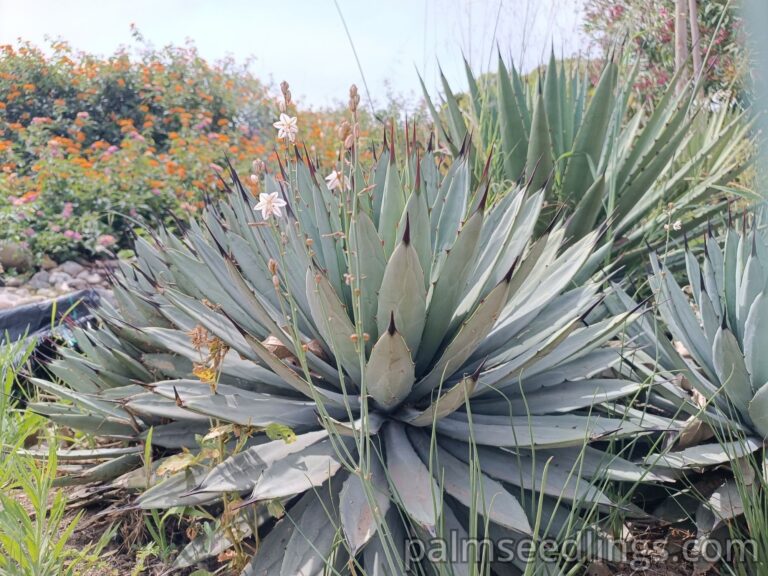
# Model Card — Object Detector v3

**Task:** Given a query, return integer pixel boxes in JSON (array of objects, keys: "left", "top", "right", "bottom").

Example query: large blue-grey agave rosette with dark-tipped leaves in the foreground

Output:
[{"left": 32, "top": 132, "right": 657, "bottom": 575}]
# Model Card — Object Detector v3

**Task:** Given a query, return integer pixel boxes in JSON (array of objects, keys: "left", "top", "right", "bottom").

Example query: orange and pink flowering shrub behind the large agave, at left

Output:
[{"left": 0, "top": 33, "right": 354, "bottom": 260}]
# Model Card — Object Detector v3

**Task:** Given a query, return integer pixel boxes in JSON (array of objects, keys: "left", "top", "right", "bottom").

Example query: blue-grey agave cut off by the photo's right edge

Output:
[{"left": 609, "top": 215, "right": 768, "bottom": 544}]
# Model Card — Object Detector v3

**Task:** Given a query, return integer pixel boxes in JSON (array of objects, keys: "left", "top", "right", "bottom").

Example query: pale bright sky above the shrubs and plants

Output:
[{"left": 0, "top": 0, "right": 586, "bottom": 106}]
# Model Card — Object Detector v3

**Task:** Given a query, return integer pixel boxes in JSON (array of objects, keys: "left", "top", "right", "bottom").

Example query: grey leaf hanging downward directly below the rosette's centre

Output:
[{"left": 384, "top": 422, "right": 440, "bottom": 534}]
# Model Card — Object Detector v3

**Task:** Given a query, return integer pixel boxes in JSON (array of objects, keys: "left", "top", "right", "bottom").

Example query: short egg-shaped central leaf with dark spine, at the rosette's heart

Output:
[{"left": 365, "top": 314, "right": 416, "bottom": 411}]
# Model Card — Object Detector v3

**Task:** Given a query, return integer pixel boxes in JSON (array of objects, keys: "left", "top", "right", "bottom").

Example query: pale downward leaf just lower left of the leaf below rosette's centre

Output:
[{"left": 339, "top": 456, "right": 390, "bottom": 556}]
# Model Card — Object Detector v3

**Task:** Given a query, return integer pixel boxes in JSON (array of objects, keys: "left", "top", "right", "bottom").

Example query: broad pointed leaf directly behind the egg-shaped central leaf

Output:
[{"left": 376, "top": 225, "right": 427, "bottom": 357}]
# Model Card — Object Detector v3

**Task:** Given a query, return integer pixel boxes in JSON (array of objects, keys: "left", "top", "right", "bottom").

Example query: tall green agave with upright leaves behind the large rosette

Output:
[{"left": 422, "top": 54, "right": 751, "bottom": 264}]
